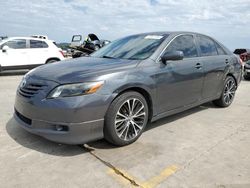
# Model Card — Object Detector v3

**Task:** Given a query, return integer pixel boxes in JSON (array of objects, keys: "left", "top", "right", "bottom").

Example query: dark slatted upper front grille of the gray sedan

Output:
[{"left": 19, "top": 83, "right": 46, "bottom": 98}]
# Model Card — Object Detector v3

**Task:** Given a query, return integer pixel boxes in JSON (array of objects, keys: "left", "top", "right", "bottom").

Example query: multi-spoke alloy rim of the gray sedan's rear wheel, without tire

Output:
[{"left": 223, "top": 79, "right": 236, "bottom": 105}]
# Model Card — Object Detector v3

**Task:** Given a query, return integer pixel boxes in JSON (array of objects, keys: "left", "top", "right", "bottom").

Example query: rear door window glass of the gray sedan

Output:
[{"left": 197, "top": 36, "right": 218, "bottom": 56}]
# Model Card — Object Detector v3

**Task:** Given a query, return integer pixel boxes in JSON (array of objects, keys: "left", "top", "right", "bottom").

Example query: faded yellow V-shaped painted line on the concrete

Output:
[{"left": 107, "top": 165, "right": 179, "bottom": 188}]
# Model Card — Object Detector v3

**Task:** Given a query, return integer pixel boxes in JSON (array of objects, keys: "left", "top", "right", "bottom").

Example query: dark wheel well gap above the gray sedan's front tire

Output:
[{"left": 116, "top": 87, "right": 153, "bottom": 121}]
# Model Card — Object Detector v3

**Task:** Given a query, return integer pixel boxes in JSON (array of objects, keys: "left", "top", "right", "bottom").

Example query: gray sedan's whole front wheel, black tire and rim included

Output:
[{"left": 104, "top": 91, "right": 148, "bottom": 146}]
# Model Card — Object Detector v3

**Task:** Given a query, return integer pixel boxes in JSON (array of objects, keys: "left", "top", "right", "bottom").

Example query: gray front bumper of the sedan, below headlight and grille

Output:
[{"left": 14, "top": 77, "right": 112, "bottom": 144}]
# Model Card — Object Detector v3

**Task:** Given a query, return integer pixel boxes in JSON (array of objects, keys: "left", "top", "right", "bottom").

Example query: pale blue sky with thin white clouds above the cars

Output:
[{"left": 0, "top": 0, "right": 250, "bottom": 50}]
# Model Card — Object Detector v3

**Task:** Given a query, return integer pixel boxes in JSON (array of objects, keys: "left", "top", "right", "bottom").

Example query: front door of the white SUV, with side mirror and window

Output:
[{"left": 0, "top": 39, "right": 29, "bottom": 68}]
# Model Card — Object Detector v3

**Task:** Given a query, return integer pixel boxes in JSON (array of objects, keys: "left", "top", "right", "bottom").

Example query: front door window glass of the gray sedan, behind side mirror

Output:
[{"left": 165, "top": 35, "right": 198, "bottom": 58}]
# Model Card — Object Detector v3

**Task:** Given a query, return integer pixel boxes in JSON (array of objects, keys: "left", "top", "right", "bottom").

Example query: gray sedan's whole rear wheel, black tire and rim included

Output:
[{"left": 213, "top": 76, "right": 237, "bottom": 107}]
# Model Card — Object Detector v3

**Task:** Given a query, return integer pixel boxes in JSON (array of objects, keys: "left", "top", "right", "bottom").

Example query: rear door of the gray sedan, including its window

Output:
[{"left": 197, "top": 35, "right": 229, "bottom": 99}]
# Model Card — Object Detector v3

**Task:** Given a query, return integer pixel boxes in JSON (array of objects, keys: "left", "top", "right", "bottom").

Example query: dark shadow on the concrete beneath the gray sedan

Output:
[{"left": 6, "top": 103, "right": 216, "bottom": 153}]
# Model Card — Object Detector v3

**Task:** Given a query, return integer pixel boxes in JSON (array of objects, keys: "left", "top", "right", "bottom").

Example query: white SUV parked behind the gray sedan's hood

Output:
[{"left": 0, "top": 37, "right": 64, "bottom": 71}]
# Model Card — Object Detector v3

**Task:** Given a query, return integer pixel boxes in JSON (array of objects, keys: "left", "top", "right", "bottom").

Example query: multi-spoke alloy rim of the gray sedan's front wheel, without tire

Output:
[{"left": 115, "top": 98, "right": 147, "bottom": 141}]
